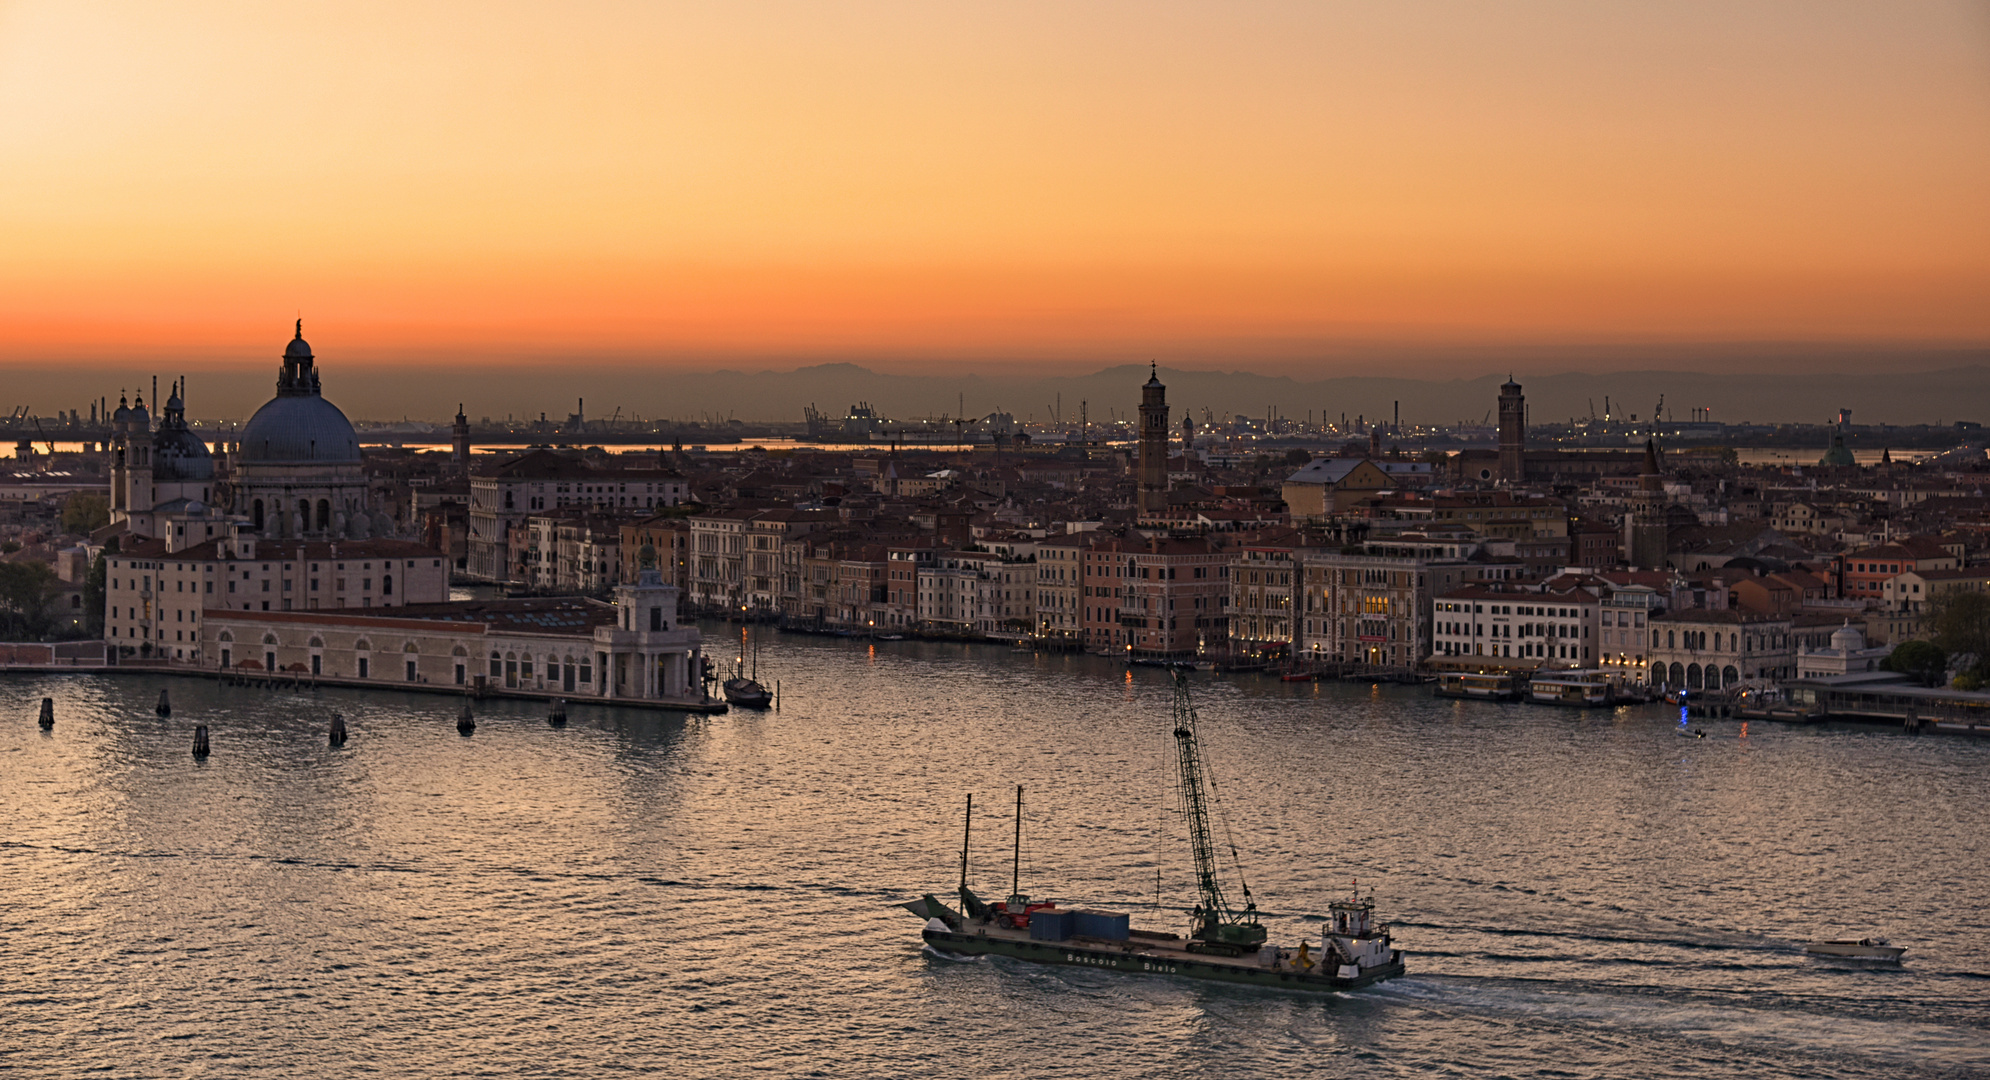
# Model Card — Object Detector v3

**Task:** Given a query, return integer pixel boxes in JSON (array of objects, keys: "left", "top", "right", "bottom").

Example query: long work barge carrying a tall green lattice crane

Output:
[{"left": 901, "top": 672, "right": 1405, "bottom": 990}]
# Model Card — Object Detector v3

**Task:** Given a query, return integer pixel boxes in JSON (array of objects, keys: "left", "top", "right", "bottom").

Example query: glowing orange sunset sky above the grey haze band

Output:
[{"left": 0, "top": 0, "right": 1990, "bottom": 370}]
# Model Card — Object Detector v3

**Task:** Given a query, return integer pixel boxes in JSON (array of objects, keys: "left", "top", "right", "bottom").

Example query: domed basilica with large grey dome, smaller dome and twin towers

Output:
[{"left": 111, "top": 320, "right": 394, "bottom": 549}]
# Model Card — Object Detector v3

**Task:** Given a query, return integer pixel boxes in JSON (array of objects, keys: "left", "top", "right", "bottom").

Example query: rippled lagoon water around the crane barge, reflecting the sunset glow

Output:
[{"left": 0, "top": 629, "right": 1990, "bottom": 1078}]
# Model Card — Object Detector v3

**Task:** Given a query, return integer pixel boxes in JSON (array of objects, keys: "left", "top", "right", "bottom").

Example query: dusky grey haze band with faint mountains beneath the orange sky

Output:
[{"left": 11, "top": 350, "right": 1990, "bottom": 424}]
